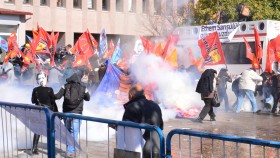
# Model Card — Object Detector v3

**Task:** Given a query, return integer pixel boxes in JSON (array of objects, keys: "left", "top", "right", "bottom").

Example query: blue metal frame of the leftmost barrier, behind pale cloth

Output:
[{"left": 0, "top": 102, "right": 51, "bottom": 158}]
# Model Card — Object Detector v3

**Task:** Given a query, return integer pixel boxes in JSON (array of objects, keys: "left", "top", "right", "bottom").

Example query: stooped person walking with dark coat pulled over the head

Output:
[{"left": 193, "top": 69, "right": 217, "bottom": 123}]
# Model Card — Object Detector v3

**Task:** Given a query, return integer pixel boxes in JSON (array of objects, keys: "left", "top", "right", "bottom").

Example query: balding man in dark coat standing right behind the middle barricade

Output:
[{"left": 122, "top": 86, "right": 163, "bottom": 158}]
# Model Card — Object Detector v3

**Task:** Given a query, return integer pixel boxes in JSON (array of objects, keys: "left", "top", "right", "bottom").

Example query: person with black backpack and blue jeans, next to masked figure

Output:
[{"left": 55, "top": 73, "right": 90, "bottom": 157}]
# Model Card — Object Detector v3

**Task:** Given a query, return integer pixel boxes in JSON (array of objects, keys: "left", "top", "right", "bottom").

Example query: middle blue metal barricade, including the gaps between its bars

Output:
[{"left": 50, "top": 113, "right": 165, "bottom": 158}]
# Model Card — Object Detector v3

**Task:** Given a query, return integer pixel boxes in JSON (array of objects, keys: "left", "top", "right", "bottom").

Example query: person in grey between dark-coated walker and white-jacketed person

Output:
[{"left": 217, "top": 68, "right": 232, "bottom": 112}]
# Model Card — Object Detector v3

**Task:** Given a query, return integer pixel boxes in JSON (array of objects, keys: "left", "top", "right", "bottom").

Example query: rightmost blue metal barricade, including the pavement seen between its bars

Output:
[{"left": 166, "top": 129, "right": 280, "bottom": 158}]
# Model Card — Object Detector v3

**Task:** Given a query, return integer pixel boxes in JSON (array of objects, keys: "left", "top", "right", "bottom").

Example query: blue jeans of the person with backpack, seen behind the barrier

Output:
[{"left": 64, "top": 118, "right": 82, "bottom": 154}]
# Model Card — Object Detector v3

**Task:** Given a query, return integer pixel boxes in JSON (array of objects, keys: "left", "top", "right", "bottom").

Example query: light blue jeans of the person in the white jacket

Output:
[{"left": 236, "top": 89, "right": 258, "bottom": 113}]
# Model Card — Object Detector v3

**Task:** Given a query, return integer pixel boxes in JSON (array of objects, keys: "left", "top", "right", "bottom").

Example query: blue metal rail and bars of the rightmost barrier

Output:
[{"left": 166, "top": 129, "right": 280, "bottom": 158}]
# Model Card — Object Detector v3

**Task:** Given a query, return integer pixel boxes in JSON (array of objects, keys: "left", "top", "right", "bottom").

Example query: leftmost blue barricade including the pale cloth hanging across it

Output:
[{"left": 0, "top": 102, "right": 50, "bottom": 157}]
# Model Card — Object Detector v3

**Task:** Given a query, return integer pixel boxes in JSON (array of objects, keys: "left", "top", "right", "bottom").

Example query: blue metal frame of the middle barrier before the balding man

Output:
[{"left": 49, "top": 113, "right": 165, "bottom": 158}]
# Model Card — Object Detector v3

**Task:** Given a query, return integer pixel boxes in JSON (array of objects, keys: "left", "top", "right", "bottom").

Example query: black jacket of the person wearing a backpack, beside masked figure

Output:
[{"left": 55, "top": 73, "right": 90, "bottom": 114}]
